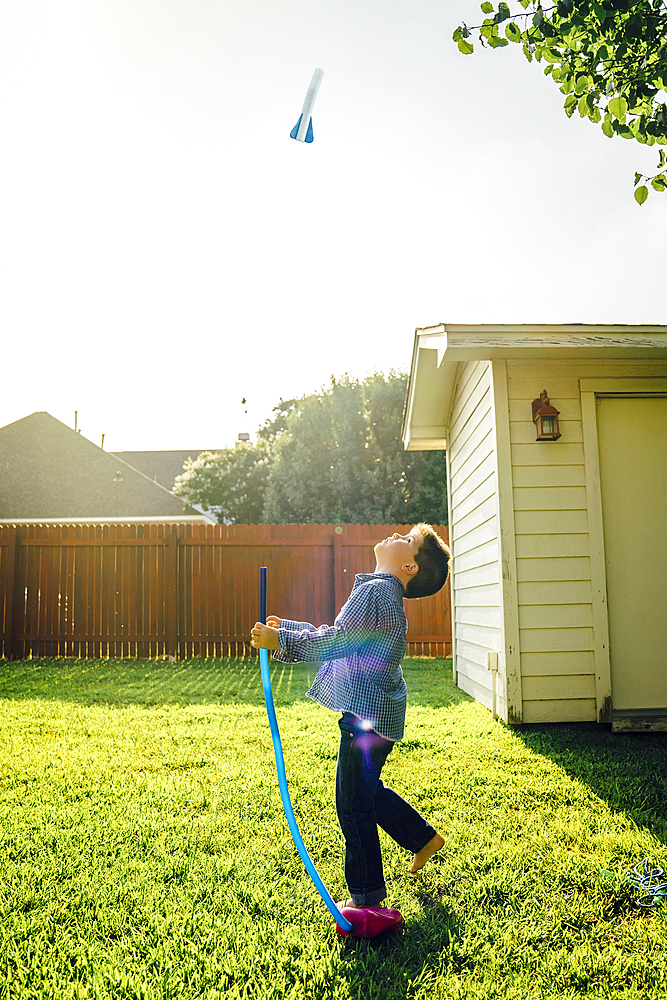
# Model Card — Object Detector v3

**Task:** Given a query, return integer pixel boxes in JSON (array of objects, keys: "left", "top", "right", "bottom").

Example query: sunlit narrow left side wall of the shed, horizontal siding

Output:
[{"left": 448, "top": 362, "right": 505, "bottom": 716}]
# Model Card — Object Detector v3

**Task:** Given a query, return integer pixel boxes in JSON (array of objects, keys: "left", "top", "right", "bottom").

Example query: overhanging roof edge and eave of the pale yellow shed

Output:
[{"left": 402, "top": 323, "right": 667, "bottom": 451}]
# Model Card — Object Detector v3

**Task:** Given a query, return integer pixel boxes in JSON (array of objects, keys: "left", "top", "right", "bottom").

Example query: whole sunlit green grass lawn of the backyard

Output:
[{"left": 0, "top": 659, "right": 667, "bottom": 1000}]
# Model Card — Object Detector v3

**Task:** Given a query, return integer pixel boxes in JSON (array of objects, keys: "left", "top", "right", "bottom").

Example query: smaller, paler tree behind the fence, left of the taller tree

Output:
[{"left": 174, "top": 441, "right": 270, "bottom": 524}]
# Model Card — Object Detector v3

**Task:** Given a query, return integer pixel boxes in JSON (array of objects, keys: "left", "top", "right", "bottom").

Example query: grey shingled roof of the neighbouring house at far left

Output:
[{"left": 0, "top": 412, "right": 215, "bottom": 523}]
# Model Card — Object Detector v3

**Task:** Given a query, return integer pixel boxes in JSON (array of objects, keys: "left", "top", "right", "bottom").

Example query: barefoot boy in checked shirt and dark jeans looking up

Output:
[{"left": 251, "top": 524, "right": 450, "bottom": 909}]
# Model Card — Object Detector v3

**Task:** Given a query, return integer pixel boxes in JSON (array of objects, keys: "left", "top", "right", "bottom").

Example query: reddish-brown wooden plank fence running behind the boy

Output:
[{"left": 0, "top": 524, "right": 451, "bottom": 659}]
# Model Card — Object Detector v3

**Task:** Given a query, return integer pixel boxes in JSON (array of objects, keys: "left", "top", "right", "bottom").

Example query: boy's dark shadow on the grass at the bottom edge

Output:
[{"left": 341, "top": 899, "right": 460, "bottom": 1000}]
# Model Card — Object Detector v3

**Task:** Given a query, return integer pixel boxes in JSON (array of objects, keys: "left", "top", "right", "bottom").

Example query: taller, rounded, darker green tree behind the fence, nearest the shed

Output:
[{"left": 260, "top": 372, "right": 447, "bottom": 524}]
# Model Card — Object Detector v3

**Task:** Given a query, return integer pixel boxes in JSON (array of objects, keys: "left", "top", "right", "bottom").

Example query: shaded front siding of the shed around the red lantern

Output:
[{"left": 507, "top": 359, "right": 667, "bottom": 722}]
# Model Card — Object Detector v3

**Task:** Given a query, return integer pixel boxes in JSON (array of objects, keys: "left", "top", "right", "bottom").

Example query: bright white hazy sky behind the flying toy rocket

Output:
[{"left": 0, "top": 0, "right": 667, "bottom": 451}]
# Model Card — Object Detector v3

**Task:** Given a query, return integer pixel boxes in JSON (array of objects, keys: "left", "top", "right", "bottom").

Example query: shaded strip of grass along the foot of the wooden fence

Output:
[{"left": 0, "top": 656, "right": 470, "bottom": 708}]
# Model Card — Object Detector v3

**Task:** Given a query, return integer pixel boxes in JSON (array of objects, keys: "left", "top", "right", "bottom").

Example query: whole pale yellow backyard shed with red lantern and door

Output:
[{"left": 403, "top": 324, "right": 667, "bottom": 731}]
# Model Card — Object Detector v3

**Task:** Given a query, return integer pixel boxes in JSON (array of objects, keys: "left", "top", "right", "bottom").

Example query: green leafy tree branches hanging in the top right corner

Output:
[{"left": 452, "top": 0, "right": 667, "bottom": 205}]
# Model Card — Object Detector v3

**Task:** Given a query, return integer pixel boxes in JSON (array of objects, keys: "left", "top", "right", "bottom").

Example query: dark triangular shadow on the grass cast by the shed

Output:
[{"left": 516, "top": 723, "right": 667, "bottom": 843}]
